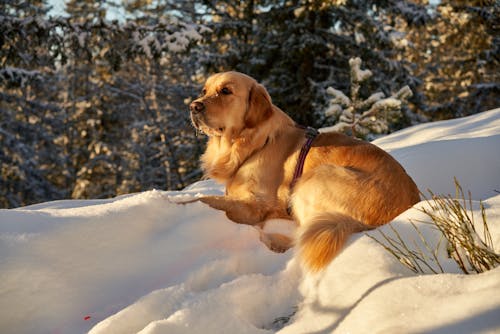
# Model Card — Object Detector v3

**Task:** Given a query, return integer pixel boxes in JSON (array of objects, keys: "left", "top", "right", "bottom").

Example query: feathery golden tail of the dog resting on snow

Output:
[{"left": 298, "top": 212, "right": 373, "bottom": 272}]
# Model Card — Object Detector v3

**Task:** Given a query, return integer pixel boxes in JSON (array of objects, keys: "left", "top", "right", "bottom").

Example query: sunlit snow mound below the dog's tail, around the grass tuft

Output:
[{"left": 279, "top": 195, "right": 500, "bottom": 334}]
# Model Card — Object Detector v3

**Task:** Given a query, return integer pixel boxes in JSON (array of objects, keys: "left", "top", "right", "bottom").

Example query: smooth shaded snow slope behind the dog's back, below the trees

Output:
[{"left": 374, "top": 109, "right": 500, "bottom": 199}]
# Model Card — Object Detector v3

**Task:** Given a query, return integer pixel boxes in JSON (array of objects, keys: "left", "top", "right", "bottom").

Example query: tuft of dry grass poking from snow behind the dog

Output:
[{"left": 370, "top": 179, "right": 500, "bottom": 274}]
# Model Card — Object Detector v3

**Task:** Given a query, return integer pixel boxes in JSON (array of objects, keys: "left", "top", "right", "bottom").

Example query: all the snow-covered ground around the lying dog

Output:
[{"left": 0, "top": 109, "right": 500, "bottom": 334}]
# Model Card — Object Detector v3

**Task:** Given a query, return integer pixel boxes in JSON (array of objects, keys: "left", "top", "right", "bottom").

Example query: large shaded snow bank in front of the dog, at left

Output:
[{"left": 0, "top": 182, "right": 289, "bottom": 333}]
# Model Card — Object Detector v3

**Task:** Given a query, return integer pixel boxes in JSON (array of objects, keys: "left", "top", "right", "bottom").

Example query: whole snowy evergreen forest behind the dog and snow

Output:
[{"left": 0, "top": 0, "right": 500, "bottom": 208}]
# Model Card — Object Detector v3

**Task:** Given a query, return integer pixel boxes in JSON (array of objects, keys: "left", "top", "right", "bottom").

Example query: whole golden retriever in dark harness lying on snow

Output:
[{"left": 189, "top": 72, "right": 420, "bottom": 272}]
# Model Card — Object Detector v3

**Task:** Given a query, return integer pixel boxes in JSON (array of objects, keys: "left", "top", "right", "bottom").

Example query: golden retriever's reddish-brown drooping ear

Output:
[{"left": 245, "top": 83, "right": 273, "bottom": 128}]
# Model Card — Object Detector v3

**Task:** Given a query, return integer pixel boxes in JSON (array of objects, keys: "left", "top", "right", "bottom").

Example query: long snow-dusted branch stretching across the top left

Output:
[{"left": 0, "top": 15, "right": 210, "bottom": 64}]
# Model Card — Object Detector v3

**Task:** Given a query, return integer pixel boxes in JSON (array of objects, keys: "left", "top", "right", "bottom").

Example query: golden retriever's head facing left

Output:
[{"left": 189, "top": 72, "right": 273, "bottom": 136}]
